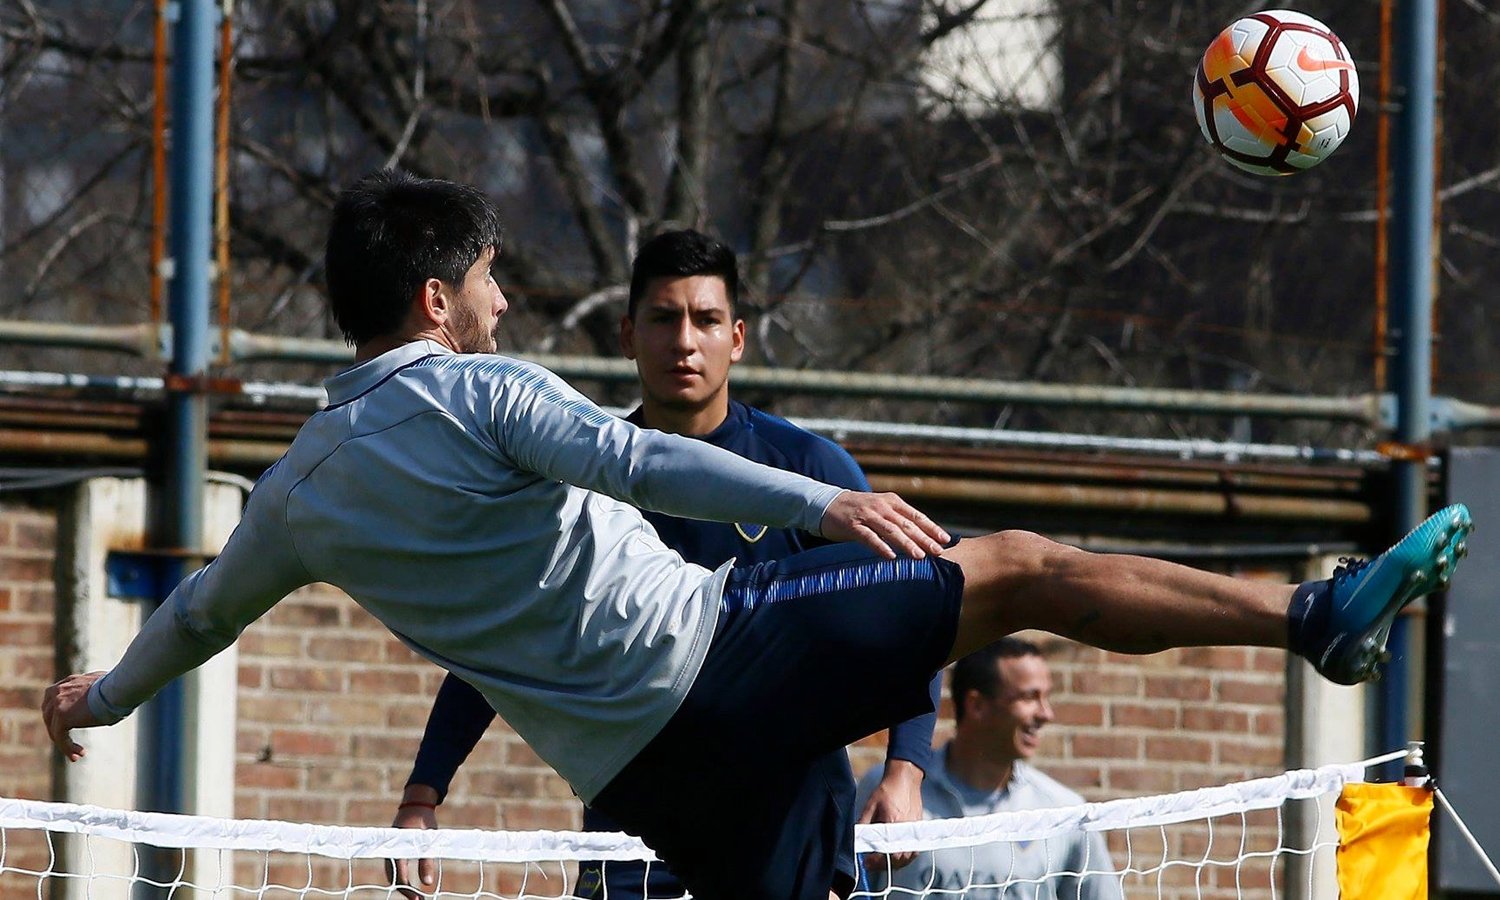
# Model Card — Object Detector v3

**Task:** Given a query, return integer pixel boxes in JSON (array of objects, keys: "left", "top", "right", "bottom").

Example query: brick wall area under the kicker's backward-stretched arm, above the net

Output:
[{"left": 236, "top": 585, "right": 578, "bottom": 830}]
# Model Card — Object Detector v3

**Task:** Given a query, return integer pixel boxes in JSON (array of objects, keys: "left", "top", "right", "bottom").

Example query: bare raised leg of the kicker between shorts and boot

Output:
[{"left": 944, "top": 531, "right": 1295, "bottom": 662}]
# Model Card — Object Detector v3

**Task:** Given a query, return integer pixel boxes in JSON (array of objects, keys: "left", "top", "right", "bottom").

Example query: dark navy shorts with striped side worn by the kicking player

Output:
[{"left": 593, "top": 545, "right": 963, "bottom": 900}]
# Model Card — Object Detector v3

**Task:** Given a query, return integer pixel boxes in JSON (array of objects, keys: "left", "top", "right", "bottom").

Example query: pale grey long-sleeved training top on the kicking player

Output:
[{"left": 89, "top": 341, "right": 842, "bottom": 801}]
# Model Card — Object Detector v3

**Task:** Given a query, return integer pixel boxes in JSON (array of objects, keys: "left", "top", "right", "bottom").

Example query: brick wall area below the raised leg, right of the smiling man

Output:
[{"left": 1038, "top": 639, "right": 1287, "bottom": 899}]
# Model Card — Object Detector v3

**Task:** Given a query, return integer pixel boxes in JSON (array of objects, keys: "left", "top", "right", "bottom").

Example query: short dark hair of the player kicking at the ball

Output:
[{"left": 324, "top": 168, "right": 501, "bottom": 344}]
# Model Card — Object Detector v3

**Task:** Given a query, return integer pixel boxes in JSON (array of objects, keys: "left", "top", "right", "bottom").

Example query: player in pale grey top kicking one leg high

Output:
[{"left": 42, "top": 171, "right": 1473, "bottom": 900}]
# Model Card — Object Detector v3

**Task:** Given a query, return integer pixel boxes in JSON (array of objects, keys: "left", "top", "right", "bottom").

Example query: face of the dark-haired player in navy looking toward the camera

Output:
[{"left": 620, "top": 275, "right": 746, "bottom": 411}]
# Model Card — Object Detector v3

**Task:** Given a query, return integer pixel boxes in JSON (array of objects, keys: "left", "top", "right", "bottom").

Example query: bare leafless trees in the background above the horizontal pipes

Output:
[{"left": 0, "top": 0, "right": 1500, "bottom": 440}]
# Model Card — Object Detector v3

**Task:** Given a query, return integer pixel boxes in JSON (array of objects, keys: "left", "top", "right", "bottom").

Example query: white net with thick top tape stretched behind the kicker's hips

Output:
[{"left": 0, "top": 761, "right": 1376, "bottom": 900}]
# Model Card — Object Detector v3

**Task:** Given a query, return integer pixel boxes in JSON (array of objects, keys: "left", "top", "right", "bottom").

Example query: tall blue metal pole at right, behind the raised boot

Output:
[{"left": 1376, "top": 0, "right": 1437, "bottom": 768}]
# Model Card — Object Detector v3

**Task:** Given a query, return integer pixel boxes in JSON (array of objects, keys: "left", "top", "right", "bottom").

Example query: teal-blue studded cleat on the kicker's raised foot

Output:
[{"left": 1308, "top": 503, "right": 1475, "bottom": 684}]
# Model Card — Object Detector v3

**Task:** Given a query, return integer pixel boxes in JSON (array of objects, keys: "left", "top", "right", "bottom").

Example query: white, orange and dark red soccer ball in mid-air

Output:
[{"left": 1193, "top": 9, "right": 1359, "bottom": 176}]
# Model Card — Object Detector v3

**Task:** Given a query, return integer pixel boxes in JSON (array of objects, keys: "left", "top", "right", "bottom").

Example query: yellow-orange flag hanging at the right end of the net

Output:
[{"left": 1337, "top": 783, "right": 1433, "bottom": 900}]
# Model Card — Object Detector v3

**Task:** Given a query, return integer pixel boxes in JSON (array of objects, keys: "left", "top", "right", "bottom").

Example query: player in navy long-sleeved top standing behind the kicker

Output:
[{"left": 393, "top": 231, "right": 941, "bottom": 900}]
